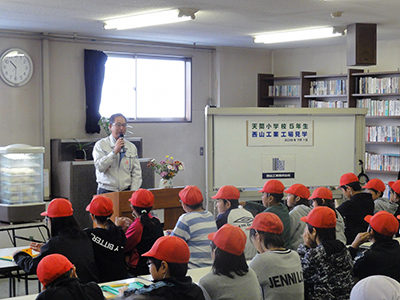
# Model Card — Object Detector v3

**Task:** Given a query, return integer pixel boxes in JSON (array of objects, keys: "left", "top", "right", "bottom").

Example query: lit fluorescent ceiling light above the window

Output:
[{"left": 104, "top": 8, "right": 197, "bottom": 30}]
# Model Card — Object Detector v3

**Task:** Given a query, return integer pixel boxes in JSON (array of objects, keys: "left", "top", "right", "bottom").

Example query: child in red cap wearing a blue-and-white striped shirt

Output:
[{"left": 171, "top": 185, "right": 217, "bottom": 268}]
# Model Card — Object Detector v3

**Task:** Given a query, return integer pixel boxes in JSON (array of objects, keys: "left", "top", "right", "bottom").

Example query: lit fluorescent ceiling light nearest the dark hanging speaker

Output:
[{"left": 254, "top": 27, "right": 344, "bottom": 44}]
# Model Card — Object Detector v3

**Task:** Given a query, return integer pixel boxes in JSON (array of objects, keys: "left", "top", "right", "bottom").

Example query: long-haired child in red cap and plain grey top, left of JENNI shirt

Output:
[{"left": 199, "top": 224, "right": 262, "bottom": 300}]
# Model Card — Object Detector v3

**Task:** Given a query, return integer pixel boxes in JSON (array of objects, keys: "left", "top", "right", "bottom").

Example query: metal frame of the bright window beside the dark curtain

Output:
[{"left": 104, "top": 51, "right": 193, "bottom": 123}]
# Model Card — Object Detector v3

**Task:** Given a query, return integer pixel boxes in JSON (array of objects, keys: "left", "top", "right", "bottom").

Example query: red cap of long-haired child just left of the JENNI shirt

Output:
[{"left": 208, "top": 224, "right": 247, "bottom": 256}]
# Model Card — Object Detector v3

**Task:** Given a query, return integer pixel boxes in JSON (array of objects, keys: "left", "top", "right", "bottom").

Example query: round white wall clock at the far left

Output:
[{"left": 0, "top": 48, "right": 33, "bottom": 86}]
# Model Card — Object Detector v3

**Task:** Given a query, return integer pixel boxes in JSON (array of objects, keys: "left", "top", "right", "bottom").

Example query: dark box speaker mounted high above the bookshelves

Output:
[{"left": 347, "top": 23, "right": 376, "bottom": 66}]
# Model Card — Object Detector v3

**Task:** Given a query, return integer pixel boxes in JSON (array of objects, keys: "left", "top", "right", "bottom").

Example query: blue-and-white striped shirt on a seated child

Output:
[{"left": 171, "top": 211, "right": 217, "bottom": 269}]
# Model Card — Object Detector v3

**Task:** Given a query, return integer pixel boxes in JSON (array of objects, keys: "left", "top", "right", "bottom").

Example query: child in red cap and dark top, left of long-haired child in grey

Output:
[{"left": 121, "top": 236, "right": 204, "bottom": 300}]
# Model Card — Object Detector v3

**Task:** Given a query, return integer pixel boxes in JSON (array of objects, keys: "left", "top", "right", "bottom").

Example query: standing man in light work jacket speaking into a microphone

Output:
[{"left": 93, "top": 114, "right": 142, "bottom": 194}]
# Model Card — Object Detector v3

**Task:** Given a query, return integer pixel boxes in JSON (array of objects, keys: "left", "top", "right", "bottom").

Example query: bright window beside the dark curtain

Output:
[{"left": 100, "top": 54, "right": 191, "bottom": 122}]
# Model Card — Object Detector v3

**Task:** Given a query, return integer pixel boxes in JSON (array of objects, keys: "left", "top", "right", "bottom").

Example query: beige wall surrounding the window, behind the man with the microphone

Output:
[{"left": 0, "top": 37, "right": 271, "bottom": 195}]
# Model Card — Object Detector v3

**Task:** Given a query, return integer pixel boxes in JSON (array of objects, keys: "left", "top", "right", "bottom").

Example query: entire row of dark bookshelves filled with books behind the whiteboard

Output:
[{"left": 258, "top": 69, "right": 400, "bottom": 183}]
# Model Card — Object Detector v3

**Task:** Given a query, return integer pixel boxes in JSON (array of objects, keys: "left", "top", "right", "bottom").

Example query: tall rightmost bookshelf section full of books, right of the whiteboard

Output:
[{"left": 350, "top": 71, "right": 400, "bottom": 183}]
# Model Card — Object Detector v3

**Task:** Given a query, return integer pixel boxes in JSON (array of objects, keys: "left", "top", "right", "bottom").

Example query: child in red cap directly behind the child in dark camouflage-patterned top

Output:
[{"left": 310, "top": 187, "right": 347, "bottom": 245}]
